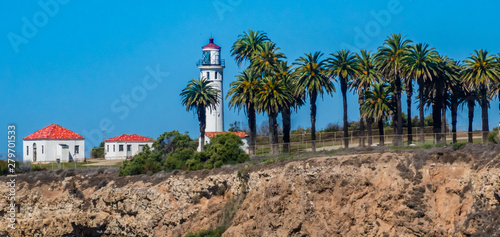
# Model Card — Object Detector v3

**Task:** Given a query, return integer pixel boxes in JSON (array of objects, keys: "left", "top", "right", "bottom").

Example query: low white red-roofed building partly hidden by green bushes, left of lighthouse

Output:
[{"left": 104, "top": 134, "right": 155, "bottom": 160}]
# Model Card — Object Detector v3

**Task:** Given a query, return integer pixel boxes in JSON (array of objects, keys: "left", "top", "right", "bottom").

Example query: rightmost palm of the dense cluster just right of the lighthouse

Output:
[{"left": 275, "top": 61, "right": 304, "bottom": 153}]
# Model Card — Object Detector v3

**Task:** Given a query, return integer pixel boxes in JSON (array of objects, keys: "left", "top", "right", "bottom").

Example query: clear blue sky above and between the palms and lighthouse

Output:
[{"left": 0, "top": 0, "right": 500, "bottom": 157}]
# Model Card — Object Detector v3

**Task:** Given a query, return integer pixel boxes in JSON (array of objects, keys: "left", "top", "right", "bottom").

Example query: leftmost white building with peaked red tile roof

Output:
[{"left": 23, "top": 124, "right": 85, "bottom": 162}]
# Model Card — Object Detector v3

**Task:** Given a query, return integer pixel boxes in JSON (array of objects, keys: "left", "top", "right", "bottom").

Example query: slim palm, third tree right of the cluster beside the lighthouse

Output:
[{"left": 352, "top": 50, "right": 380, "bottom": 146}]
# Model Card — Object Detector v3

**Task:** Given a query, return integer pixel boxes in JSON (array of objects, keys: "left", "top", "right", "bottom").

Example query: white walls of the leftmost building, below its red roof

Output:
[{"left": 23, "top": 139, "right": 85, "bottom": 162}]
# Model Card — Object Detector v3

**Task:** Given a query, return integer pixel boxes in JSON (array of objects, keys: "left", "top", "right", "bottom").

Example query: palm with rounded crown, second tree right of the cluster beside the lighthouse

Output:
[{"left": 327, "top": 50, "right": 358, "bottom": 148}]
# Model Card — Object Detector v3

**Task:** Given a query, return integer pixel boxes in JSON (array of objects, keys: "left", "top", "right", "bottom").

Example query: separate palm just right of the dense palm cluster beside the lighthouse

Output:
[{"left": 294, "top": 52, "right": 335, "bottom": 152}]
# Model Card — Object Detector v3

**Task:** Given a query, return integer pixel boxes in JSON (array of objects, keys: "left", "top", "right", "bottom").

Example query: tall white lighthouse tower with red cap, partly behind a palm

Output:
[{"left": 196, "top": 38, "right": 225, "bottom": 132}]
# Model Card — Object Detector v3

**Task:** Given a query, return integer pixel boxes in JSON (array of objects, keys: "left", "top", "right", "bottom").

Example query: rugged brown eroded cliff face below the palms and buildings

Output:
[{"left": 0, "top": 145, "right": 500, "bottom": 236}]
